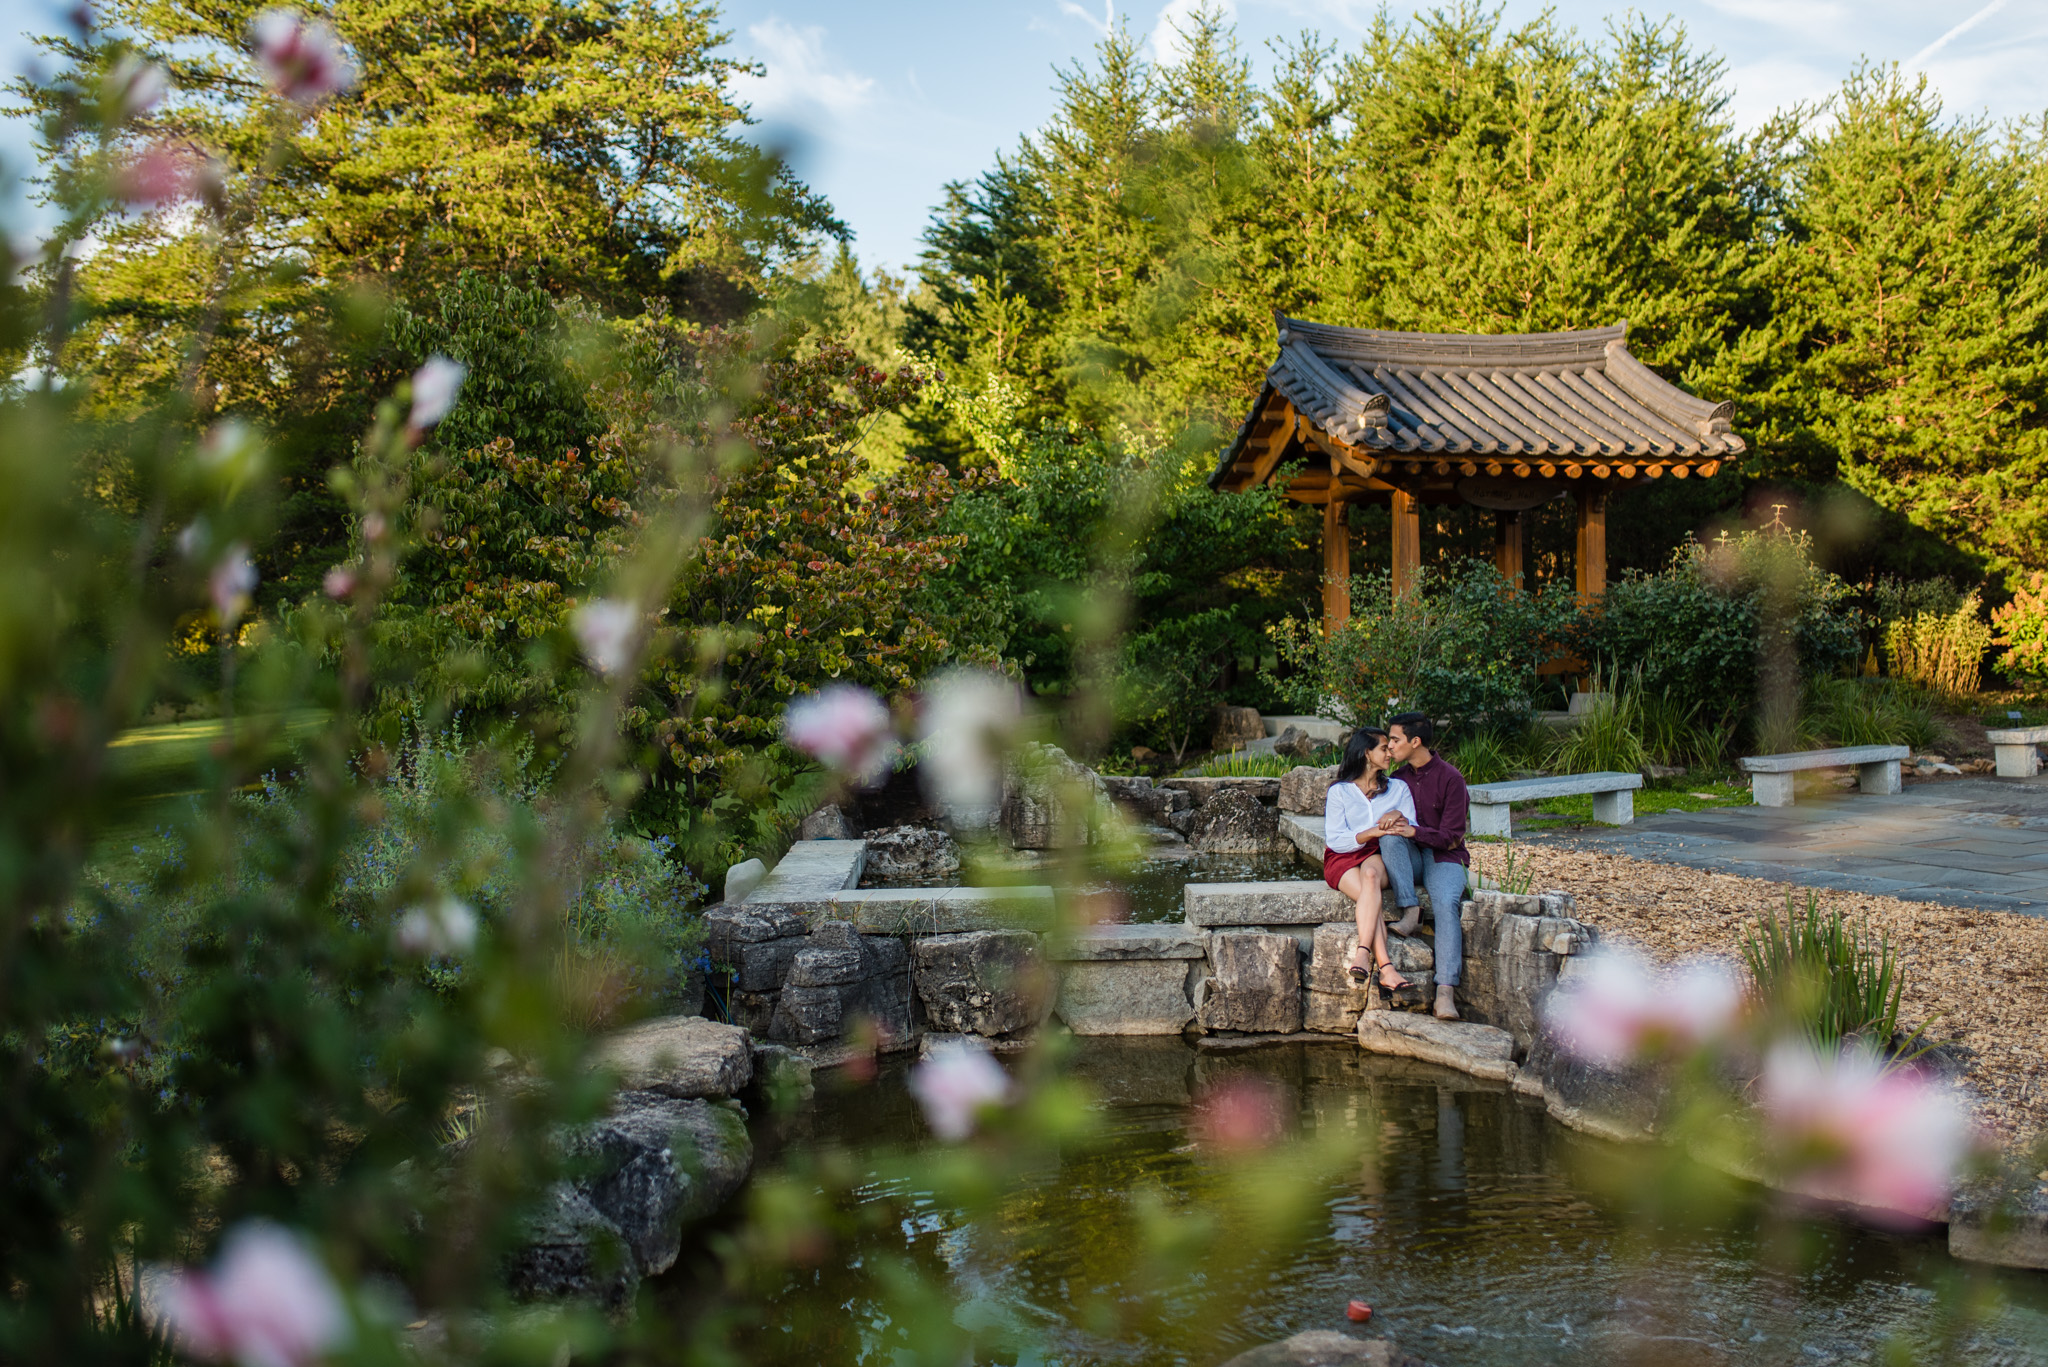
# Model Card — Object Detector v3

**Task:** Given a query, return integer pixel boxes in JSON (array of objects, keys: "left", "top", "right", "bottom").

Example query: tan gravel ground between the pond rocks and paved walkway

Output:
[{"left": 1507, "top": 840, "right": 2048, "bottom": 1148}]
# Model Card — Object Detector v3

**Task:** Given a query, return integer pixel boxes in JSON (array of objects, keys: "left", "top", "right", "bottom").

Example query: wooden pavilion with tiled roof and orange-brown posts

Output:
[{"left": 1208, "top": 314, "right": 1745, "bottom": 629}]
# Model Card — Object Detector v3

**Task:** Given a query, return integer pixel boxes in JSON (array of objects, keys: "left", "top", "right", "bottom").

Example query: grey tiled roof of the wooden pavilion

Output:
[{"left": 1217, "top": 318, "right": 1745, "bottom": 489}]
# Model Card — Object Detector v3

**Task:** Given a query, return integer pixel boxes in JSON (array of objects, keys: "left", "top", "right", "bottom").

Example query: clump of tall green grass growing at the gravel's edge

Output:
[{"left": 1743, "top": 892, "right": 1929, "bottom": 1064}]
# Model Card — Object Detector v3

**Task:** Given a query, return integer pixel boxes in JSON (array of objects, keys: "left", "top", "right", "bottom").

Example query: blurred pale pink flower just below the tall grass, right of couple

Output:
[{"left": 1544, "top": 951, "right": 1743, "bottom": 1068}]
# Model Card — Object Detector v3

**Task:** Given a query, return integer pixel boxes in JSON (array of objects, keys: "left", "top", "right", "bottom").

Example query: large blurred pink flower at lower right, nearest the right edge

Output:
[{"left": 1757, "top": 1039, "right": 1976, "bottom": 1219}]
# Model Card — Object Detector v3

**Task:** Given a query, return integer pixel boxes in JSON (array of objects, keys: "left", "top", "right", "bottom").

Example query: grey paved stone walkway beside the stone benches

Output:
[{"left": 1516, "top": 775, "right": 2048, "bottom": 916}]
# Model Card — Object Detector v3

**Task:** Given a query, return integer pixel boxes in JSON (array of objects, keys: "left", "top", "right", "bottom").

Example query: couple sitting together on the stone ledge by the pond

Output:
[{"left": 1323, "top": 711, "right": 1468, "bottom": 1021}]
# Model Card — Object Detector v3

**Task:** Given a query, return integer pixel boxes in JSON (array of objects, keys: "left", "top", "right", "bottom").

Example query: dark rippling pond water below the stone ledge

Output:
[{"left": 668, "top": 1039, "right": 2048, "bottom": 1367}]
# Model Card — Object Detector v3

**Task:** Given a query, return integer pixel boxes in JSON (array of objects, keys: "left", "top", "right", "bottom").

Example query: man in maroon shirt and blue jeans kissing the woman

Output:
[{"left": 1380, "top": 711, "right": 1470, "bottom": 1021}]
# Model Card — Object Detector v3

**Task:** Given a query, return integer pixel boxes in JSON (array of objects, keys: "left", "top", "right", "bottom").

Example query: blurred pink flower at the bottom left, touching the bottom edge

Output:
[{"left": 154, "top": 1219, "right": 348, "bottom": 1367}]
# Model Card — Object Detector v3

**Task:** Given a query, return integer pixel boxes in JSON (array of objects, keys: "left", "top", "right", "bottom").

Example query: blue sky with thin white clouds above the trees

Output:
[{"left": 0, "top": 0, "right": 2048, "bottom": 271}]
